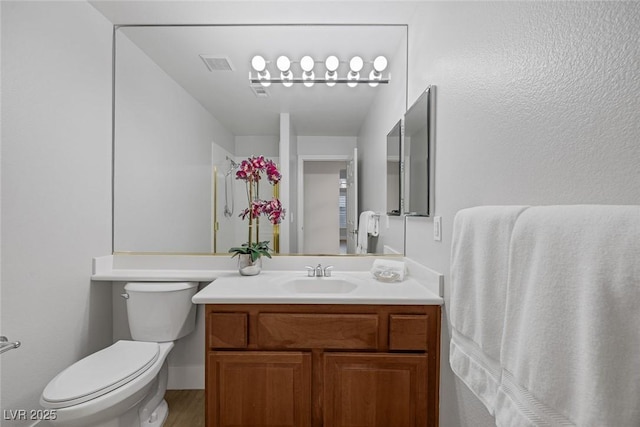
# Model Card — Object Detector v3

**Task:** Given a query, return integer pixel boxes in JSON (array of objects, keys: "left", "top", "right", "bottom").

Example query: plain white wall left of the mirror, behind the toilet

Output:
[{"left": 0, "top": 1, "right": 111, "bottom": 427}]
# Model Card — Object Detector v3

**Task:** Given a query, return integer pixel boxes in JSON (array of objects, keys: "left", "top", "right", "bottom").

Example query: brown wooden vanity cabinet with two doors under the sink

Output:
[{"left": 206, "top": 304, "right": 440, "bottom": 427}]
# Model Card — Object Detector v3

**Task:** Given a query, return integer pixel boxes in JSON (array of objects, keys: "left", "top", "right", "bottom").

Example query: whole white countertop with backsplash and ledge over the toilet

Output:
[{"left": 91, "top": 254, "right": 444, "bottom": 305}]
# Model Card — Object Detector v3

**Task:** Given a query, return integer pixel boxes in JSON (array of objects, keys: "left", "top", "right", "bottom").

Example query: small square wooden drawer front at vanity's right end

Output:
[{"left": 389, "top": 314, "right": 428, "bottom": 351}]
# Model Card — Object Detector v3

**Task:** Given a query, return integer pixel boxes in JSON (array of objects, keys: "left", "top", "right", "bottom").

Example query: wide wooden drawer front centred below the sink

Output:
[{"left": 258, "top": 313, "right": 378, "bottom": 350}]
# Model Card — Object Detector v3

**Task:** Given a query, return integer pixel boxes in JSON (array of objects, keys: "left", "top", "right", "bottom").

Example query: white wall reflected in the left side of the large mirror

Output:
[{"left": 114, "top": 32, "right": 234, "bottom": 253}]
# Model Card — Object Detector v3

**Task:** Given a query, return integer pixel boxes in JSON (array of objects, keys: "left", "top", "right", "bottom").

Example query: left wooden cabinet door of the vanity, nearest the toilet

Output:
[{"left": 207, "top": 351, "right": 311, "bottom": 427}]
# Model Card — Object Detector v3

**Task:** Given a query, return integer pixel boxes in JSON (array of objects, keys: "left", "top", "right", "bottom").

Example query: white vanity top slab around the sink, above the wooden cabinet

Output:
[{"left": 192, "top": 270, "right": 443, "bottom": 305}]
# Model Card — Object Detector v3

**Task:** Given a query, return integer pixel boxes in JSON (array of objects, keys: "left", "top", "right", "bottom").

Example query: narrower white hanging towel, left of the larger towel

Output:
[{"left": 449, "top": 206, "right": 527, "bottom": 414}]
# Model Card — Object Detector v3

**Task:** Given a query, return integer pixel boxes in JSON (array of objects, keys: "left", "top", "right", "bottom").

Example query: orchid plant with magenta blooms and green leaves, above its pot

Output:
[{"left": 229, "top": 156, "right": 285, "bottom": 262}]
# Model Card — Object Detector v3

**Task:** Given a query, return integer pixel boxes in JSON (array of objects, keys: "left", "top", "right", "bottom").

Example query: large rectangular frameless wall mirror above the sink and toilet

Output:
[{"left": 113, "top": 25, "right": 407, "bottom": 254}]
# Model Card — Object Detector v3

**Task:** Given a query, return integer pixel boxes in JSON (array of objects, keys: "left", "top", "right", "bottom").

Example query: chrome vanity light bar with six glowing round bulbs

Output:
[{"left": 249, "top": 55, "right": 390, "bottom": 87}]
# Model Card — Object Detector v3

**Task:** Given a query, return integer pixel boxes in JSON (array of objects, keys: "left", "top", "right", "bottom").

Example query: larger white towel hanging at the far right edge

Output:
[{"left": 498, "top": 205, "right": 640, "bottom": 427}]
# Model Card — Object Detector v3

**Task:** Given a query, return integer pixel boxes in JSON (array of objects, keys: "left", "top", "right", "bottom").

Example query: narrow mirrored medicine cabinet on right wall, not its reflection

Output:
[{"left": 402, "top": 86, "right": 435, "bottom": 216}]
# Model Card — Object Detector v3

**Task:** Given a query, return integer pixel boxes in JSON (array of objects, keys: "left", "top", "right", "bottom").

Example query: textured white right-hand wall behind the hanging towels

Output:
[{"left": 407, "top": 2, "right": 640, "bottom": 427}]
